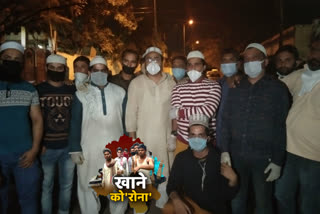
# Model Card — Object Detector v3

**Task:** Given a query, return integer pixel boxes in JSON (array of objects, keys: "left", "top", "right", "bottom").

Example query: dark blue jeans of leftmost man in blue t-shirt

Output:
[{"left": 0, "top": 153, "right": 40, "bottom": 214}]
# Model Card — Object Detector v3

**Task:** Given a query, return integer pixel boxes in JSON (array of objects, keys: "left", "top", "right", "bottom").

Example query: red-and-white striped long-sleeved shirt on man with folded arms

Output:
[{"left": 171, "top": 79, "right": 221, "bottom": 144}]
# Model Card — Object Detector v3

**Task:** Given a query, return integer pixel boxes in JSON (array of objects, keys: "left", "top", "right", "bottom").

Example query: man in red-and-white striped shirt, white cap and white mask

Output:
[{"left": 169, "top": 50, "right": 221, "bottom": 154}]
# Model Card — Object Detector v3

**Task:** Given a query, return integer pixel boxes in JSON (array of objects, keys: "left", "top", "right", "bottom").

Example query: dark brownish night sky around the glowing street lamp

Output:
[{"left": 134, "top": 0, "right": 320, "bottom": 55}]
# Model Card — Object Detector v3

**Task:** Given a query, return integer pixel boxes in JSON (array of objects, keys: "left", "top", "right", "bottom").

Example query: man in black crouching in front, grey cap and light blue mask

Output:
[{"left": 163, "top": 114, "right": 238, "bottom": 214}]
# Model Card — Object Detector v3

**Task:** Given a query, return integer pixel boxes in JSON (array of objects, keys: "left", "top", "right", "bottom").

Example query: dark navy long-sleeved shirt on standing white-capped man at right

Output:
[{"left": 220, "top": 75, "right": 290, "bottom": 166}]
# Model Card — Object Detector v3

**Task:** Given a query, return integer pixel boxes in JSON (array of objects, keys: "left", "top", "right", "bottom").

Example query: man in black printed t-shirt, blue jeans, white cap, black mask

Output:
[{"left": 37, "top": 54, "right": 76, "bottom": 214}]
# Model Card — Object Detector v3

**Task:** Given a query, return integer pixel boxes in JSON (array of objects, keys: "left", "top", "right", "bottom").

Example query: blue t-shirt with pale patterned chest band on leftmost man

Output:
[{"left": 0, "top": 81, "right": 39, "bottom": 154}]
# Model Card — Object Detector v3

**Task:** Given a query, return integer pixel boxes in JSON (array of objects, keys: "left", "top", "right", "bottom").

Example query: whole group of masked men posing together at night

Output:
[{"left": 0, "top": 32, "right": 320, "bottom": 214}]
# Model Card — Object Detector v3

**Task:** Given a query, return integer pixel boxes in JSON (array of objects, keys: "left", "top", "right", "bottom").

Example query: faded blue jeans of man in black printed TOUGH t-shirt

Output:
[{"left": 41, "top": 148, "right": 75, "bottom": 214}]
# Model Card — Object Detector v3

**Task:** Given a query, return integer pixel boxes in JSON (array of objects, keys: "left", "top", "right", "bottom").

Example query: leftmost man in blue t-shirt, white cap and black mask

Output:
[{"left": 0, "top": 42, "right": 43, "bottom": 214}]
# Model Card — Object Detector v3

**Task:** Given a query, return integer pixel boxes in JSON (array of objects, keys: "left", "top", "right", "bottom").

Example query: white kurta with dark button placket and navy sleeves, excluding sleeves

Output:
[{"left": 76, "top": 83, "right": 125, "bottom": 214}]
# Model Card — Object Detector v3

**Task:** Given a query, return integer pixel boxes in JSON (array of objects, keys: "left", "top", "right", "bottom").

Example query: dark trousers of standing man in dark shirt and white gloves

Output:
[{"left": 231, "top": 157, "right": 273, "bottom": 214}]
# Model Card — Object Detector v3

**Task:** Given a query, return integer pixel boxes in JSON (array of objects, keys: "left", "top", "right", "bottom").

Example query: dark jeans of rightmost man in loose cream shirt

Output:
[{"left": 276, "top": 153, "right": 320, "bottom": 214}]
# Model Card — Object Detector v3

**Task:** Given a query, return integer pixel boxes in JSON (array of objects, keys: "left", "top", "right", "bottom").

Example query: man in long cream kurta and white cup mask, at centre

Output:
[{"left": 126, "top": 47, "right": 175, "bottom": 208}]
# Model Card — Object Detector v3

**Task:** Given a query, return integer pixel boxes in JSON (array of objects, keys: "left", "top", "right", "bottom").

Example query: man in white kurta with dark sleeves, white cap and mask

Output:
[{"left": 69, "top": 56, "right": 125, "bottom": 214}]
